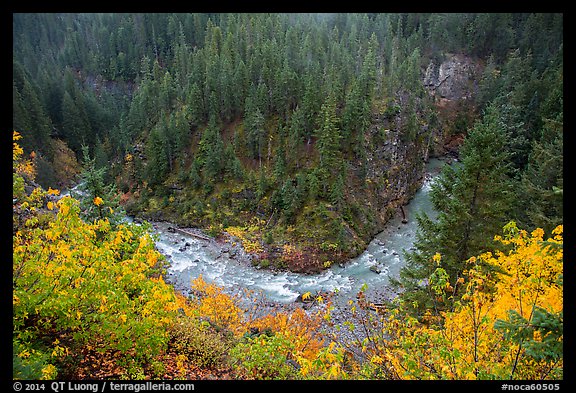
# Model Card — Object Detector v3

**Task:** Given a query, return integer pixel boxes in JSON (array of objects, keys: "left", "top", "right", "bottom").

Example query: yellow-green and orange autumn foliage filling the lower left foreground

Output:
[{"left": 13, "top": 133, "right": 338, "bottom": 379}]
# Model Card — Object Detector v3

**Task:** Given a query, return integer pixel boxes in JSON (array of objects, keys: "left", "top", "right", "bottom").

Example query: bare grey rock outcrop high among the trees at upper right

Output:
[{"left": 424, "top": 54, "right": 481, "bottom": 101}]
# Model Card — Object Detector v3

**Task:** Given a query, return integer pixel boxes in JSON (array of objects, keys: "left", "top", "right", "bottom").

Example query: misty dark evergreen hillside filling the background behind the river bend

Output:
[{"left": 13, "top": 14, "right": 562, "bottom": 270}]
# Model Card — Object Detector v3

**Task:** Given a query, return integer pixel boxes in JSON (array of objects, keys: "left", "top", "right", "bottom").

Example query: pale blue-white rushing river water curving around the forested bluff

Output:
[{"left": 153, "top": 159, "right": 446, "bottom": 303}]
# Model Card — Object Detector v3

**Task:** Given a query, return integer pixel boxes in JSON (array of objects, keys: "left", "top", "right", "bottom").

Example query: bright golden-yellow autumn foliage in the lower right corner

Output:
[{"left": 354, "top": 222, "right": 563, "bottom": 380}]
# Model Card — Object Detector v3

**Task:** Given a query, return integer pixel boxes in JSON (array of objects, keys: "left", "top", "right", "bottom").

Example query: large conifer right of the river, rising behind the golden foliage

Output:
[{"left": 394, "top": 102, "right": 513, "bottom": 309}]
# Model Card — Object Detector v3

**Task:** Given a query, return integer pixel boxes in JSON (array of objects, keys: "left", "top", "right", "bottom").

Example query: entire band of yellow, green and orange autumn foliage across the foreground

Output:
[{"left": 12, "top": 132, "right": 563, "bottom": 380}]
